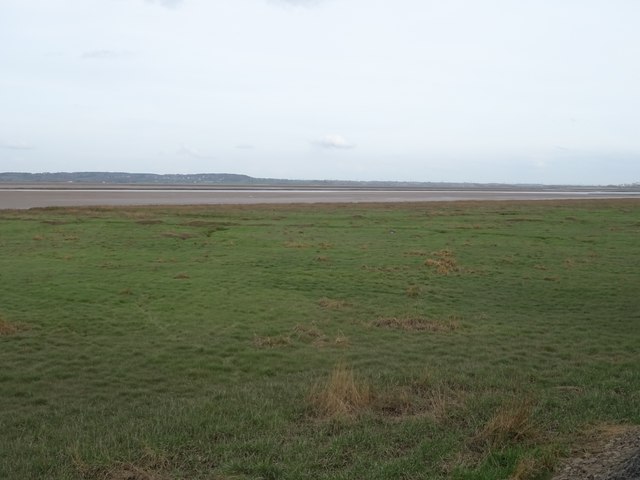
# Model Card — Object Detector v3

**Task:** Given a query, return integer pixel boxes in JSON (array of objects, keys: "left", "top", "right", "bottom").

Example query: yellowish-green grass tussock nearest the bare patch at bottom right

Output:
[{"left": 473, "top": 398, "right": 536, "bottom": 448}]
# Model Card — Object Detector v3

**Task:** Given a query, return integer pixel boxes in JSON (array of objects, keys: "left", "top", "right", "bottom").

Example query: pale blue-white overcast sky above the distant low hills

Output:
[{"left": 0, "top": 0, "right": 640, "bottom": 185}]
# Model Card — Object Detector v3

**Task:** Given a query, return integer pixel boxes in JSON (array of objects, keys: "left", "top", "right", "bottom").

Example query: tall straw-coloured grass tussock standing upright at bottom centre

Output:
[{"left": 308, "top": 363, "right": 373, "bottom": 418}]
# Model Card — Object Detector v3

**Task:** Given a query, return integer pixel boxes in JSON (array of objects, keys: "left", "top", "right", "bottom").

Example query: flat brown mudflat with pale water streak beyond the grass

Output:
[{"left": 0, "top": 185, "right": 640, "bottom": 209}]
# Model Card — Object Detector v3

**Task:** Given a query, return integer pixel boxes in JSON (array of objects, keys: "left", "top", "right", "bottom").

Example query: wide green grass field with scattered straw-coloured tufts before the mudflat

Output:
[{"left": 0, "top": 200, "right": 640, "bottom": 480}]
